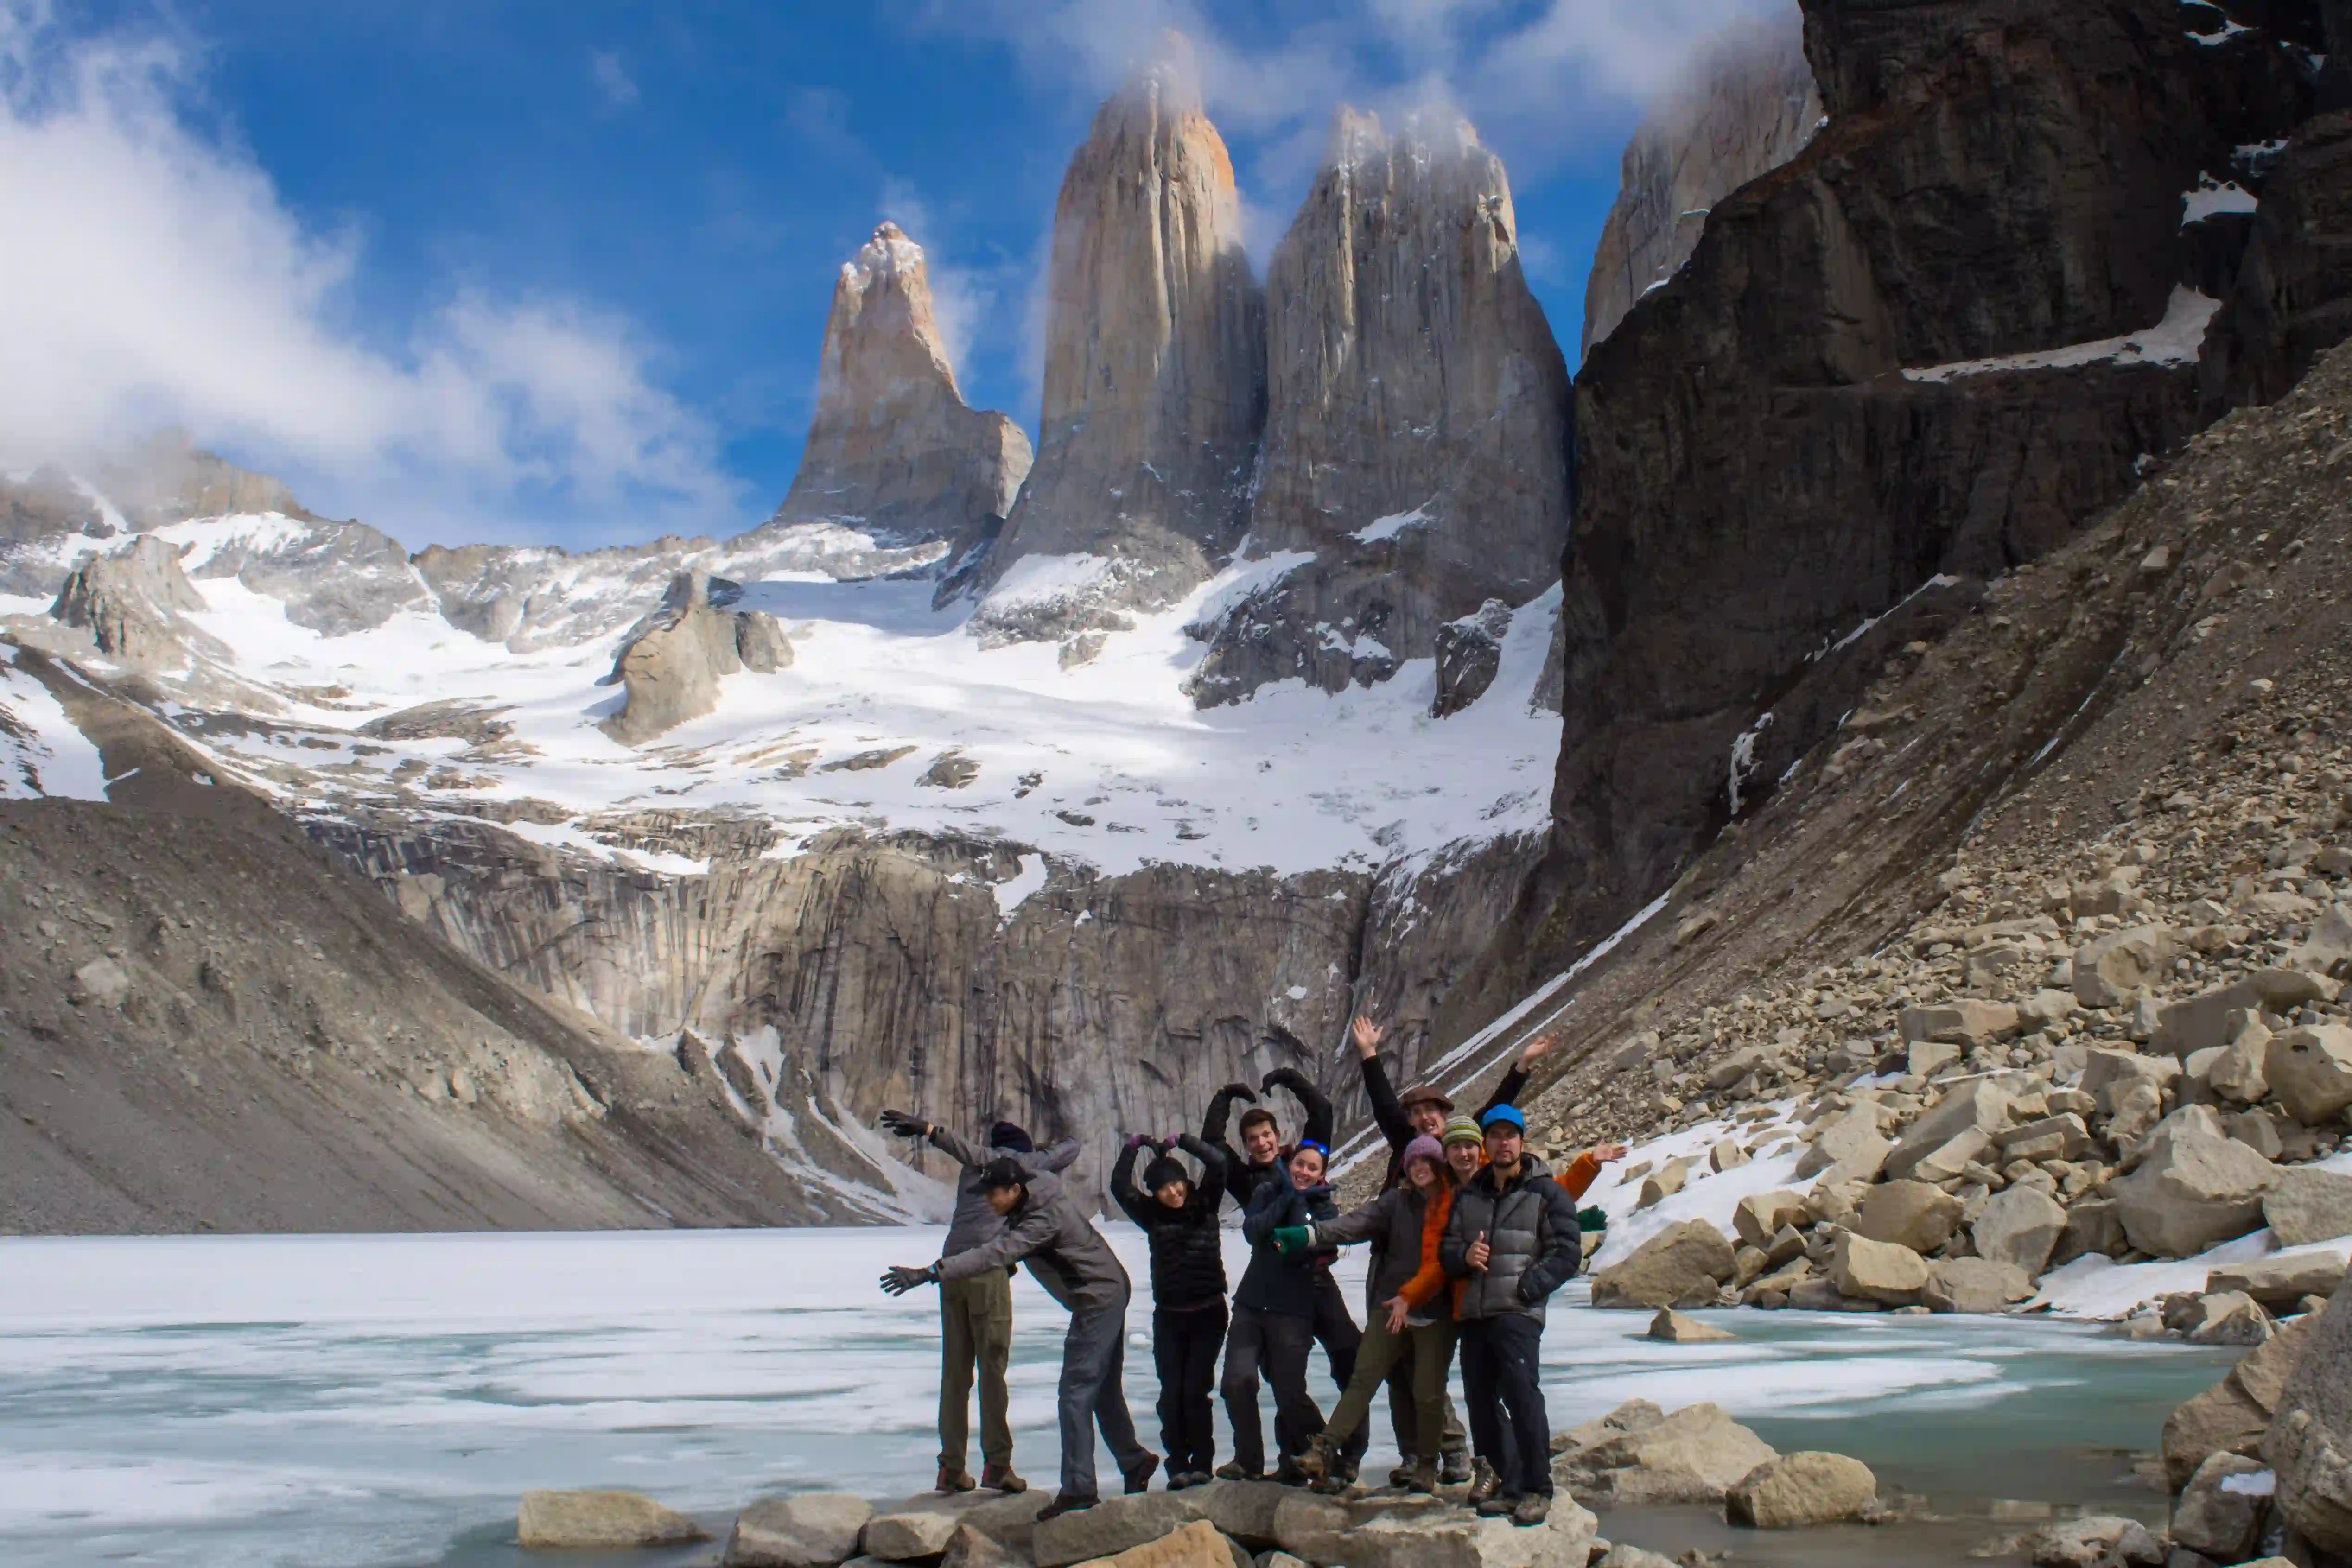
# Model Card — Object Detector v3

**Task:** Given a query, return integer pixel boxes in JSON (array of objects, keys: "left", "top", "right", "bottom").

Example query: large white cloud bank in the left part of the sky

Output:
[{"left": 0, "top": 0, "right": 734, "bottom": 543}]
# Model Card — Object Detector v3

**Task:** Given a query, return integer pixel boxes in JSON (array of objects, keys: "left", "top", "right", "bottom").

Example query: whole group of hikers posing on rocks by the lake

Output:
[{"left": 882, "top": 1018, "right": 1625, "bottom": 1526}]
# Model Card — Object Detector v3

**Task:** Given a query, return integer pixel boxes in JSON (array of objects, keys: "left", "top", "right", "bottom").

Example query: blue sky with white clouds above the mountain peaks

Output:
[{"left": 0, "top": 0, "right": 1780, "bottom": 548}]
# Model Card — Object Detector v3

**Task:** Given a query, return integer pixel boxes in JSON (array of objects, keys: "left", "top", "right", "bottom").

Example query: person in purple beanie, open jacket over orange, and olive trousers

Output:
[{"left": 1275, "top": 1138, "right": 1456, "bottom": 1493}]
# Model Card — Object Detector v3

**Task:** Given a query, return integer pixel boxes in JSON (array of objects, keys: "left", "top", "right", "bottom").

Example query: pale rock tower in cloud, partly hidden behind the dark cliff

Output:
[{"left": 1583, "top": 5, "right": 1820, "bottom": 355}]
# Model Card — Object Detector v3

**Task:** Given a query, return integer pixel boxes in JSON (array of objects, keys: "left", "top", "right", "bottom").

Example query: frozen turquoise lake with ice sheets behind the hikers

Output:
[{"left": 0, "top": 1225, "right": 2230, "bottom": 1568}]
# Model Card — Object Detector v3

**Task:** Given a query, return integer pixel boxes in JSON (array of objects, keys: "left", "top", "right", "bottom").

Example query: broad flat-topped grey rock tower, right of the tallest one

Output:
[{"left": 1195, "top": 110, "right": 1569, "bottom": 703}]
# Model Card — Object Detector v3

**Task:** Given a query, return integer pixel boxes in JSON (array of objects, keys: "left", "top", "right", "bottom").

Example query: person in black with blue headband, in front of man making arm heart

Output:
[{"left": 1218, "top": 1143, "right": 1362, "bottom": 1485}]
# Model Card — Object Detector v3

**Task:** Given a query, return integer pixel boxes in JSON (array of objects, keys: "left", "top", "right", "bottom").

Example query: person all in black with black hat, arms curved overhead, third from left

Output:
[{"left": 1110, "top": 1133, "right": 1226, "bottom": 1493}]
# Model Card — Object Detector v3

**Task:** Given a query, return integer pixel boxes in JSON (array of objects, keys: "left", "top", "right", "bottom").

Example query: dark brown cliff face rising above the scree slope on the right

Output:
[{"left": 1545, "top": 0, "right": 2312, "bottom": 968}]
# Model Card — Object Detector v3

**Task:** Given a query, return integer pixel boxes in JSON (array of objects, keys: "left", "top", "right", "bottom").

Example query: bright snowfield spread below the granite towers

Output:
[{"left": 9, "top": 517, "right": 1559, "bottom": 875}]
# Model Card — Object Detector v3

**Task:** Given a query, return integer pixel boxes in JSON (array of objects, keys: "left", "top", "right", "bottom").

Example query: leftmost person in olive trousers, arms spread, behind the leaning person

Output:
[{"left": 882, "top": 1110, "right": 1077, "bottom": 1493}]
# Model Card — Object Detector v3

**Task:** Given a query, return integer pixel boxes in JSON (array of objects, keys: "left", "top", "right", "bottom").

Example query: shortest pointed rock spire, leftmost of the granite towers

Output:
[{"left": 774, "top": 223, "right": 1030, "bottom": 564}]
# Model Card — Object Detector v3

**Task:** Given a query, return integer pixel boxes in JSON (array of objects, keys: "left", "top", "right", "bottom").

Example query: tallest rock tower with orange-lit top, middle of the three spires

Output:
[{"left": 981, "top": 44, "right": 1265, "bottom": 637}]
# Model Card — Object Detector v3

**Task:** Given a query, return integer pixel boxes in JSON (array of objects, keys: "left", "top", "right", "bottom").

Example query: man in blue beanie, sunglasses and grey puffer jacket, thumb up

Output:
[{"left": 1439, "top": 1105, "right": 1583, "bottom": 1526}]
